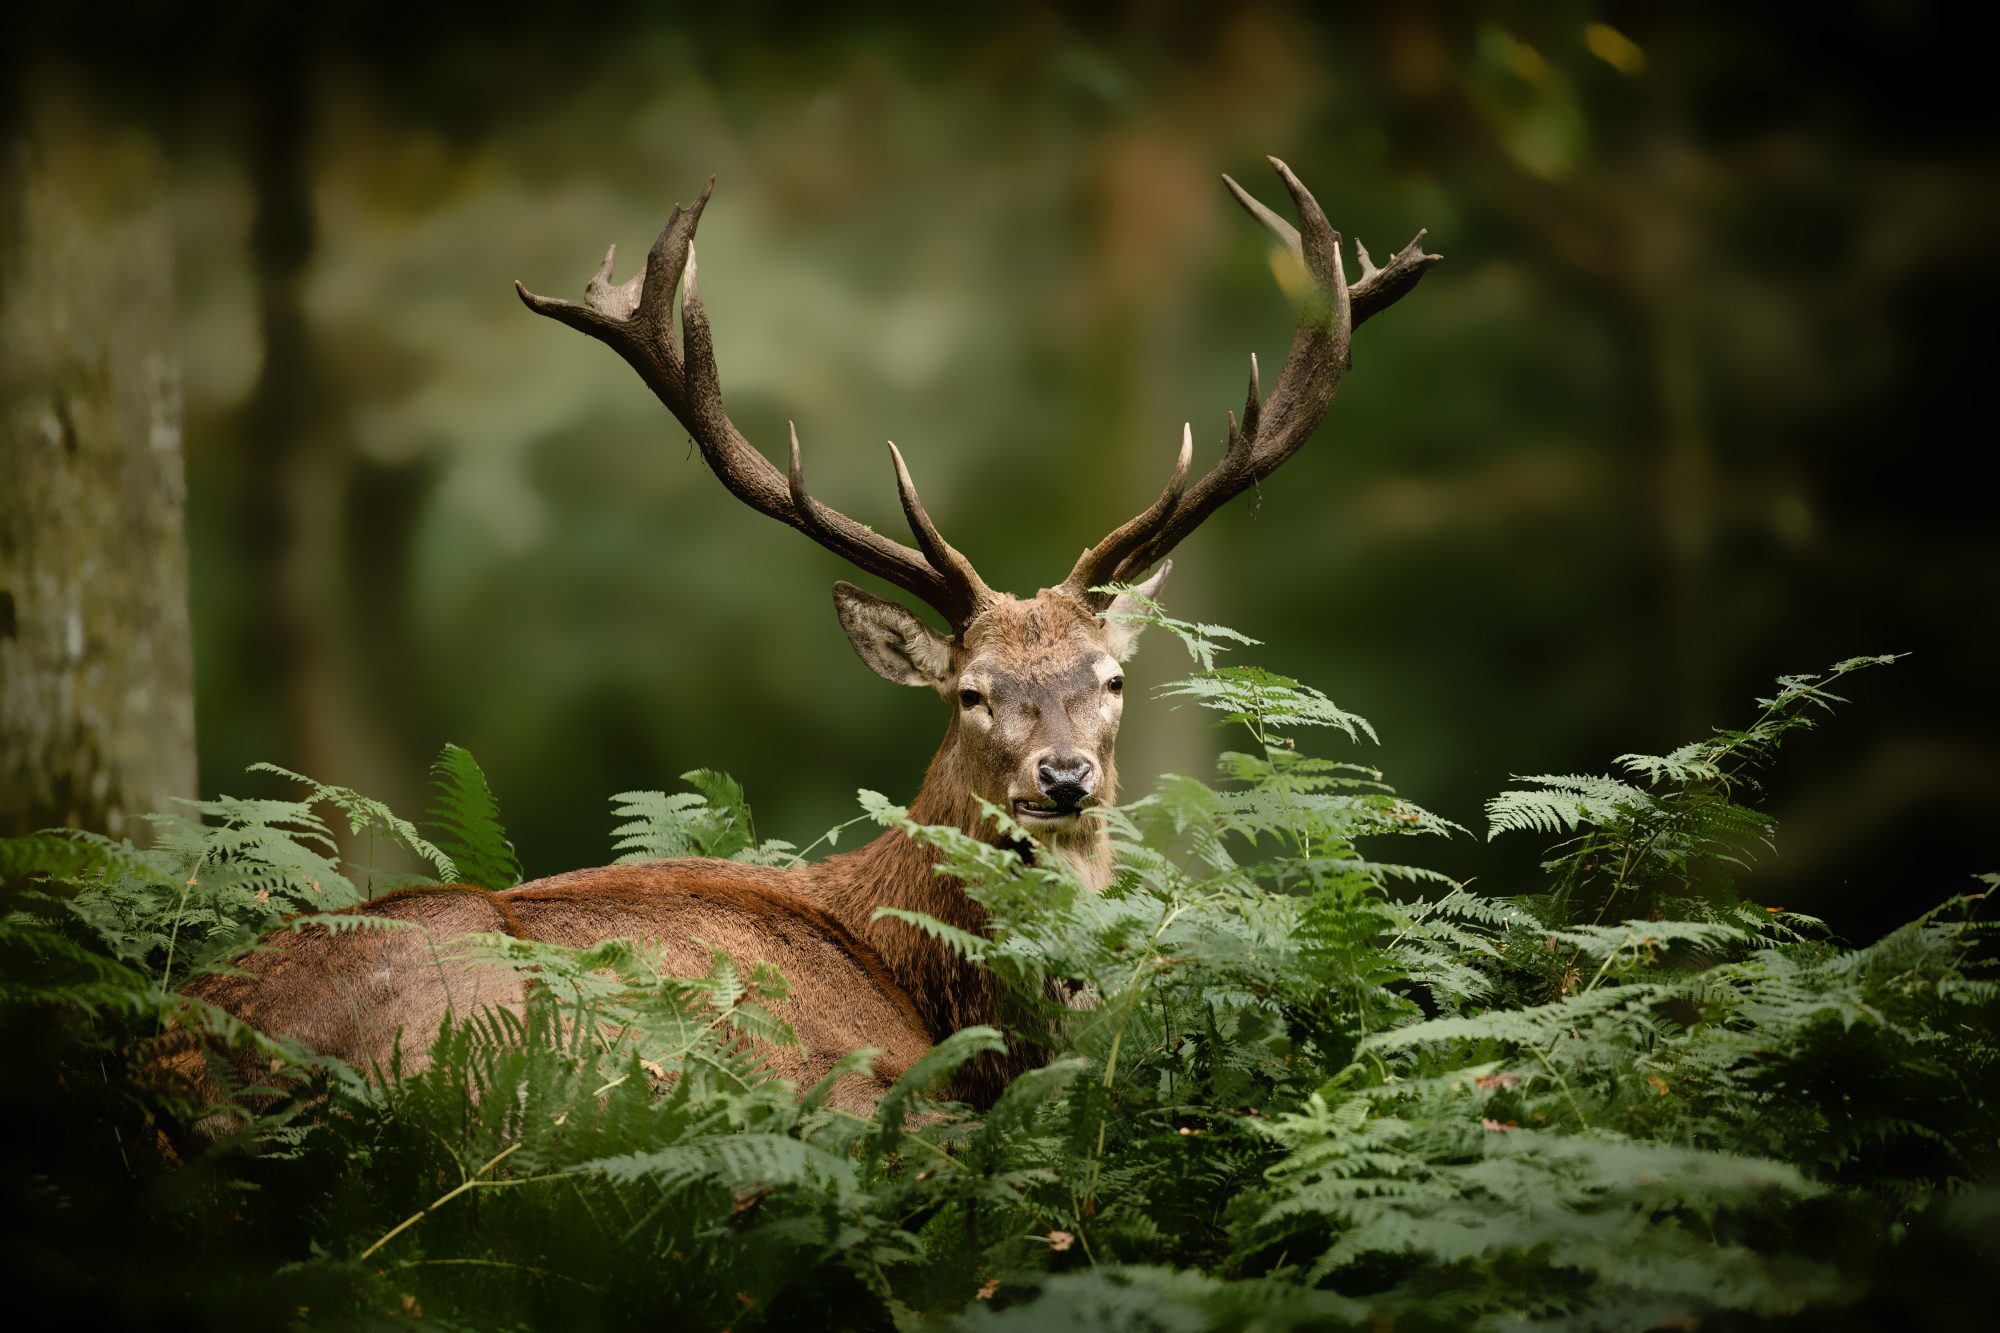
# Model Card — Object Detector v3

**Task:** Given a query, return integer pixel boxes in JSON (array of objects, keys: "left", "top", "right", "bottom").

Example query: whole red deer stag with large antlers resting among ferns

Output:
[{"left": 180, "top": 158, "right": 1438, "bottom": 1107}]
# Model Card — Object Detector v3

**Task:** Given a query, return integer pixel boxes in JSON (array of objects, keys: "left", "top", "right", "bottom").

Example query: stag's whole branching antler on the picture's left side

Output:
[{"left": 514, "top": 178, "right": 994, "bottom": 630}]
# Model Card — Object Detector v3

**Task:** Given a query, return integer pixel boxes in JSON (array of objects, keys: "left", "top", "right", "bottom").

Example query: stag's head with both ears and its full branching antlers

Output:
[{"left": 514, "top": 158, "right": 1438, "bottom": 869}]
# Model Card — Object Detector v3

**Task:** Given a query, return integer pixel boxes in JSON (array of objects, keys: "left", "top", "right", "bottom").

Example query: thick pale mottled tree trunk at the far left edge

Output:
[{"left": 0, "top": 80, "right": 194, "bottom": 835}]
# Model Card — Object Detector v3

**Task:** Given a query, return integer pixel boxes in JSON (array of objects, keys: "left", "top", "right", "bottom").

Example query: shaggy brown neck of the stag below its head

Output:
[{"left": 812, "top": 737, "right": 1112, "bottom": 1039}]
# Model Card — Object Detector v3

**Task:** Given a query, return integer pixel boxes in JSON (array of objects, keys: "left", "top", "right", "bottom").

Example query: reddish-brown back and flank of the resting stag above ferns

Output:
[{"left": 162, "top": 859, "right": 932, "bottom": 1129}]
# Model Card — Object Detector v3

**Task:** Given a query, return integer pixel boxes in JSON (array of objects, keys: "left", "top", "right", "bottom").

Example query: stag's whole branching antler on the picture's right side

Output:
[{"left": 1066, "top": 158, "right": 1440, "bottom": 600}]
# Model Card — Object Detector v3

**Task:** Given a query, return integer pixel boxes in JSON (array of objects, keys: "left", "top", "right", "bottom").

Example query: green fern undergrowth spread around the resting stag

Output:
[{"left": 0, "top": 640, "right": 2000, "bottom": 1329}]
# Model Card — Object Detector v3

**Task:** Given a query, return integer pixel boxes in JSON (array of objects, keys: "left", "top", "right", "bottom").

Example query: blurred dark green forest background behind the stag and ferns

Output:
[{"left": 0, "top": 2, "right": 2000, "bottom": 939}]
